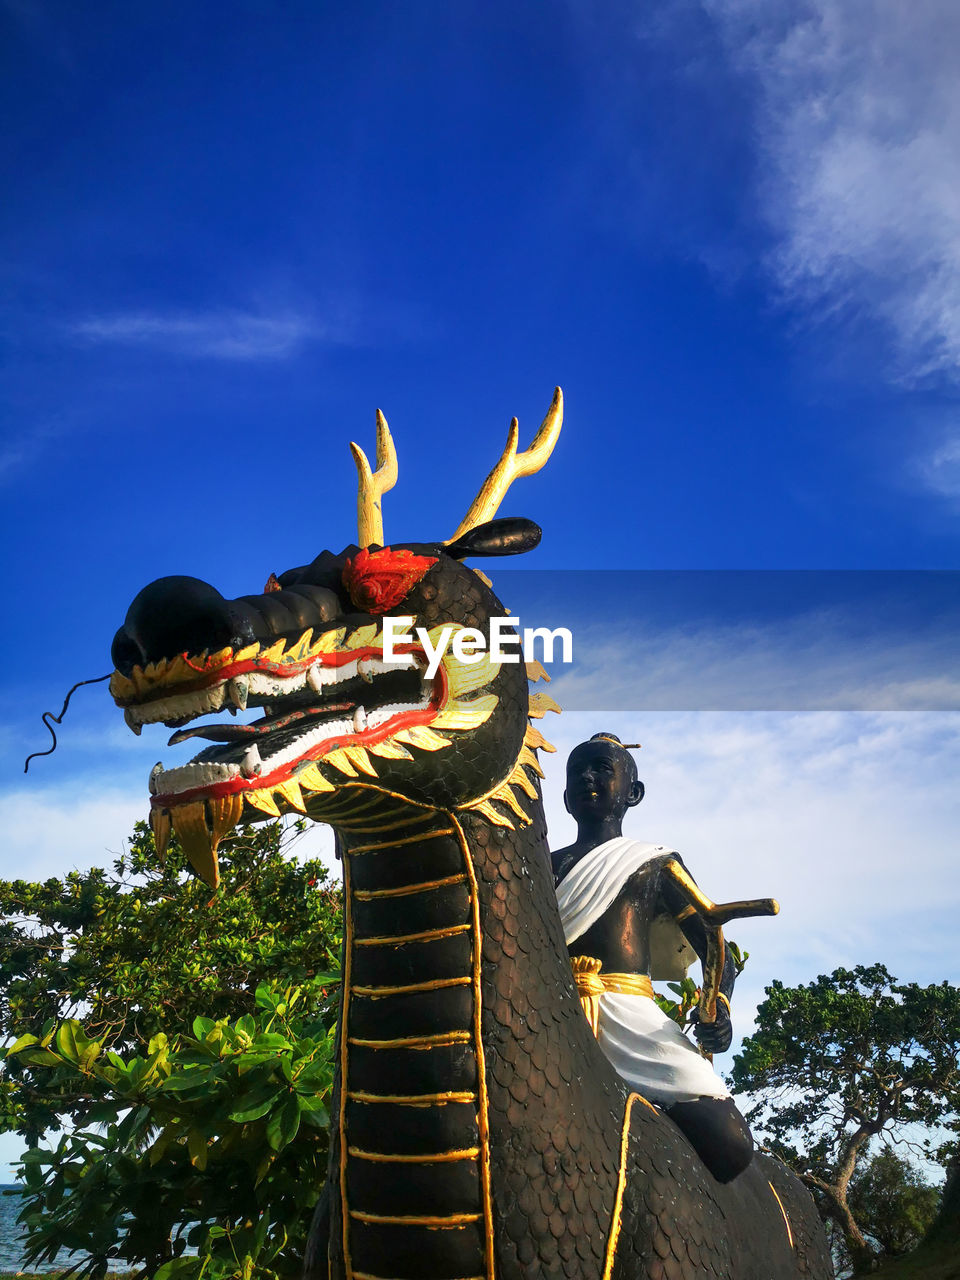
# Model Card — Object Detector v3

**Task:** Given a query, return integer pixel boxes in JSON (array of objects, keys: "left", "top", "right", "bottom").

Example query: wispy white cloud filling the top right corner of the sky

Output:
[{"left": 703, "top": 0, "right": 960, "bottom": 380}]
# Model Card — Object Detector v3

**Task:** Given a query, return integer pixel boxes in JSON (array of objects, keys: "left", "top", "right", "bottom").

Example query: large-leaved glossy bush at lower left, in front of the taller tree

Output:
[{"left": 8, "top": 979, "right": 334, "bottom": 1280}]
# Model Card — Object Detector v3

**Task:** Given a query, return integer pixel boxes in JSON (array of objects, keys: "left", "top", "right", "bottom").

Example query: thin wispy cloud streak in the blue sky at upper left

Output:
[{"left": 70, "top": 310, "right": 337, "bottom": 360}]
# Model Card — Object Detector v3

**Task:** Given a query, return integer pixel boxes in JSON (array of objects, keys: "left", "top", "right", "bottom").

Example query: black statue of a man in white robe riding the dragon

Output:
[{"left": 552, "top": 733, "right": 753, "bottom": 1183}]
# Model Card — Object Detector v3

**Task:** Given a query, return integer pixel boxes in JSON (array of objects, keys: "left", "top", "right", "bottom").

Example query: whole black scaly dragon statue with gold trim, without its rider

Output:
[{"left": 111, "top": 389, "right": 833, "bottom": 1280}]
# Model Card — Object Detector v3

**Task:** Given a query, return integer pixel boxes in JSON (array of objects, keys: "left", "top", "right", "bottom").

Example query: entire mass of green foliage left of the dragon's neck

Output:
[{"left": 0, "top": 823, "right": 340, "bottom": 1280}]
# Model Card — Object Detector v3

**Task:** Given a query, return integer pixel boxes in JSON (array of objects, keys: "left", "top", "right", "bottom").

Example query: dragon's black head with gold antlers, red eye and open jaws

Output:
[{"left": 110, "top": 388, "right": 563, "bottom": 884}]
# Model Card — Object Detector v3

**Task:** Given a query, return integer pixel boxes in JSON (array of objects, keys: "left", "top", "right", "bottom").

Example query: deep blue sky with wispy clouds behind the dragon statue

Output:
[{"left": 0, "top": 0, "right": 960, "bottom": 1172}]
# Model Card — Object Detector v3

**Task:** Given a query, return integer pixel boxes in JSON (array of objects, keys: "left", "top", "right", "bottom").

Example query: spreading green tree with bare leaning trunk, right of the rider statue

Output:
[{"left": 731, "top": 964, "right": 960, "bottom": 1272}]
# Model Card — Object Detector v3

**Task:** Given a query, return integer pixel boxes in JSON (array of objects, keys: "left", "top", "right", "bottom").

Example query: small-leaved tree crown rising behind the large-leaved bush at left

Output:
[{"left": 0, "top": 823, "right": 342, "bottom": 1143}]
